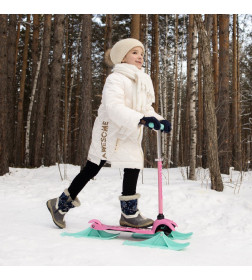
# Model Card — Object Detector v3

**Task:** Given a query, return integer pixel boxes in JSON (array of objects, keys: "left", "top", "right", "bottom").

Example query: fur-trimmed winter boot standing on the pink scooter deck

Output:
[{"left": 119, "top": 194, "right": 154, "bottom": 228}]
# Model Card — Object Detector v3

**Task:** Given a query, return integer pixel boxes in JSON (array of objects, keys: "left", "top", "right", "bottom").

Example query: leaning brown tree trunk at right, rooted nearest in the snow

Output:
[{"left": 194, "top": 15, "right": 223, "bottom": 191}]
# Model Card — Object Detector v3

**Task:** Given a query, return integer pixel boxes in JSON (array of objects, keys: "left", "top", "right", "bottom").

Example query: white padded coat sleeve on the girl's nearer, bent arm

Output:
[{"left": 102, "top": 73, "right": 144, "bottom": 129}]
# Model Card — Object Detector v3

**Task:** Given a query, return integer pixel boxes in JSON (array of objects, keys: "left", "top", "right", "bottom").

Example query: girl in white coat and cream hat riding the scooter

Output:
[{"left": 47, "top": 38, "right": 171, "bottom": 228}]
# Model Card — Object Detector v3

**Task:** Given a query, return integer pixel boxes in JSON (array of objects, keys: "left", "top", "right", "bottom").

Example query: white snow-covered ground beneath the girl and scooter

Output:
[{"left": 0, "top": 165, "right": 252, "bottom": 272}]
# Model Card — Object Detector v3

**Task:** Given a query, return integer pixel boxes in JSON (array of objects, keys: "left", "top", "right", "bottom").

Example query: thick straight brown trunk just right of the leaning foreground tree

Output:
[{"left": 217, "top": 15, "right": 231, "bottom": 174}]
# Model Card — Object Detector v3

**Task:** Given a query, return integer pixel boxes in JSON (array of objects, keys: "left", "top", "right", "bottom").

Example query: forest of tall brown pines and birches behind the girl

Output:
[{"left": 0, "top": 9, "right": 252, "bottom": 190}]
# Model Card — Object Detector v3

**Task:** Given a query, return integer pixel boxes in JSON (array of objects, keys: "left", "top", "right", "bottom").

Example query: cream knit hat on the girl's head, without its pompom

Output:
[{"left": 107, "top": 38, "right": 144, "bottom": 64}]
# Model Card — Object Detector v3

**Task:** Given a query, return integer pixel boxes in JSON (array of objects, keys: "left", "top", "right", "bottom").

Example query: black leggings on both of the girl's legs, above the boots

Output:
[{"left": 68, "top": 160, "right": 140, "bottom": 199}]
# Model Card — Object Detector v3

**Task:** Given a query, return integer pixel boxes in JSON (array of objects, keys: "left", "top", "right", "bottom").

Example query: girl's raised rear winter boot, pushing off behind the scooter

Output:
[{"left": 46, "top": 189, "right": 81, "bottom": 228}]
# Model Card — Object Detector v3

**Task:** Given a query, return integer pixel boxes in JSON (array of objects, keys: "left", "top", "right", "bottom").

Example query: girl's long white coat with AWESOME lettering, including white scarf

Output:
[{"left": 88, "top": 64, "right": 163, "bottom": 169}]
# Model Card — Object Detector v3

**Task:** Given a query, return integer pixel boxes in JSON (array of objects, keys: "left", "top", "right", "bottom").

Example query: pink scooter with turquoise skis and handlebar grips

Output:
[{"left": 62, "top": 123, "right": 193, "bottom": 250}]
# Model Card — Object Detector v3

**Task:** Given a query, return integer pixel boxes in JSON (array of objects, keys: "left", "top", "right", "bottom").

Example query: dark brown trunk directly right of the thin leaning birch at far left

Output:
[{"left": 34, "top": 15, "right": 52, "bottom": 167}]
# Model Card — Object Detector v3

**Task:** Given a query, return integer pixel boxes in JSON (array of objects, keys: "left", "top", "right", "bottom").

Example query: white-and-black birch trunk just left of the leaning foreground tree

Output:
[{"left": 189, "top": 15, "right": 197, "bottom": 180}]
